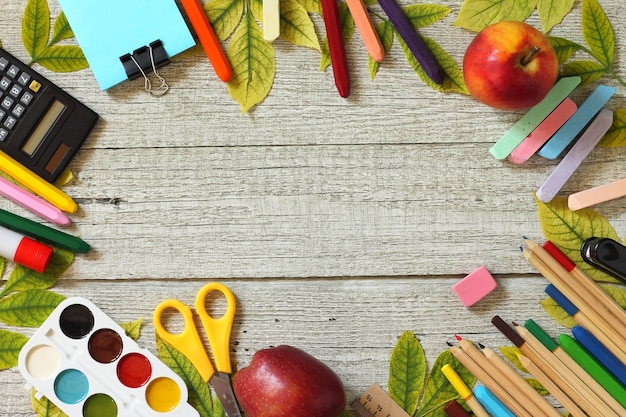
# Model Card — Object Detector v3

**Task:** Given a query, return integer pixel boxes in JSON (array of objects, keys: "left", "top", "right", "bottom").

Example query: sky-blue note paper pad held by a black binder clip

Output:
[{"left": 59, "top": 0, "right": 195, "bottom": 90}]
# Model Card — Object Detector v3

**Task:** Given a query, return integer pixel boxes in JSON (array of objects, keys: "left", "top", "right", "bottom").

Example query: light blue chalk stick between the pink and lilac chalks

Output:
[{"left": 539, "top": 85, "right": 615, "bottom": 159}]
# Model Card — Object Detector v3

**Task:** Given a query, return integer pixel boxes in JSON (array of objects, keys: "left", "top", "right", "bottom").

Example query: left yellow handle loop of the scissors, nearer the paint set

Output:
[{"left": 153, "top": 300, "right": 215, "bottom": 382}]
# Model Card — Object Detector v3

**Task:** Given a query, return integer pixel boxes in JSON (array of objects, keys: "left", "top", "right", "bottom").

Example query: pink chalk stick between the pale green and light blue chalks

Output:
[{"left": 509, "top": 98, "right": 578, "bottom": 164}]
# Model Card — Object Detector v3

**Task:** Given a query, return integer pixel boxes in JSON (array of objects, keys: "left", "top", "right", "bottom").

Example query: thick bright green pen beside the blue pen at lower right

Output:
[{"left": 559, "top": 334, "right": 626, "bottom": 411}]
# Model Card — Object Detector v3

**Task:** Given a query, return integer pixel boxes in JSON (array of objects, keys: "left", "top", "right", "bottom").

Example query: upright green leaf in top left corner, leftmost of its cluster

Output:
[{"left": 22, "top": 0, "right": 50, "bottom": 59}]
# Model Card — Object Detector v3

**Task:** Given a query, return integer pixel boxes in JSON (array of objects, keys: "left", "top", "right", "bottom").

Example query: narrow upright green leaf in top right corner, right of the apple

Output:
[{"left": 582, "top": 0, "right": 615, "bottom": 68}]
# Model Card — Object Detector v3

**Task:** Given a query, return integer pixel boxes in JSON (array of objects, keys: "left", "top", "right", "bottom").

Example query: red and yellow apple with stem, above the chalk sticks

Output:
[{"left": 463, "top": 21, "right": 559, "bottom": 110}]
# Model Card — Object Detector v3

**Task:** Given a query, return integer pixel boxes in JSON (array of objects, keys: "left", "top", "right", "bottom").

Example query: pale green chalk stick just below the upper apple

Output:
[{"left": 489, "top": 77, "right": 580, "bottom": 159}]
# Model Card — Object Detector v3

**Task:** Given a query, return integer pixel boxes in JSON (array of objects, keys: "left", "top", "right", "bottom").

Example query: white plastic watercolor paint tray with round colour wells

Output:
[{"left": 19, "top": 297, "right": 198, "bottom": 417}]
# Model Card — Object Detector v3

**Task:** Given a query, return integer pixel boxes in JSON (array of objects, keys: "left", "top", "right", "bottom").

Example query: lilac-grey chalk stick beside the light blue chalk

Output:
[{"left": 537, "top": 109, "right": 613, "bottom": 203}]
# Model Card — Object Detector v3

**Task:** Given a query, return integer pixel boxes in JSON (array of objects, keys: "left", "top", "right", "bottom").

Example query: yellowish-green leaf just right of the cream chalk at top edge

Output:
[{"left": 280, "top": 0, "right": 321, "bottom": 51}]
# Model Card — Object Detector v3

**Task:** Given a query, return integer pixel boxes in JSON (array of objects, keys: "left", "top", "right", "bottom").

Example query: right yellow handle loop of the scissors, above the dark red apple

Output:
[{"left": 194, "top": 282, "right": 237, "bottom": 374}]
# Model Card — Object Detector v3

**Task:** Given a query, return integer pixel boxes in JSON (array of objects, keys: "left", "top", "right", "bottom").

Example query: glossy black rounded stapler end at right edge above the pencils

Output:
[{"left": 580, "top": 237, "right": 626, "bottom": 283}]
